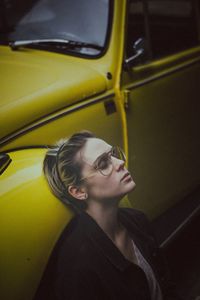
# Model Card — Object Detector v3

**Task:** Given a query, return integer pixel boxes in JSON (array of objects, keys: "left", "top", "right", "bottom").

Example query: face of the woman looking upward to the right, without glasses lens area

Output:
[{"left": 78, "top": 138, "right": 135, "bottom": 201}]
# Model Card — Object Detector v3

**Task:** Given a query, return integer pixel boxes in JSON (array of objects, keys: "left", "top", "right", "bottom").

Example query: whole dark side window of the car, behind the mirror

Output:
[{"left": 127, "top": 0, "right": 200, "bottom": 59}]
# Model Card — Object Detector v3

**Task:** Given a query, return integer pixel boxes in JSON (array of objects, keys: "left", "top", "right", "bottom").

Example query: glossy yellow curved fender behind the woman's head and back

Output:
[{"left": 0, "top": 149, "right": 73, "bottom": 300}]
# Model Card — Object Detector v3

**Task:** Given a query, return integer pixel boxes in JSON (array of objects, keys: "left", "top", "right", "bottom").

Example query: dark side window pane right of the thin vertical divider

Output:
[{"left": 148, "top": 0, "right": 198, "bottom": 57}]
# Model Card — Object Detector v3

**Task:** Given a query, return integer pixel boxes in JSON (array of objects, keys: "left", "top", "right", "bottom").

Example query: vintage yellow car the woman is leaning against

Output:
[{"left": 0, "top": 0, "right": 200, "bottom": 300}]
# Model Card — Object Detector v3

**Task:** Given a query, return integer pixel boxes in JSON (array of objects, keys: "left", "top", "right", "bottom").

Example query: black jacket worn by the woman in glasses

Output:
[{"left": 34, "top": 208, "right": 179, "bottom": 300}]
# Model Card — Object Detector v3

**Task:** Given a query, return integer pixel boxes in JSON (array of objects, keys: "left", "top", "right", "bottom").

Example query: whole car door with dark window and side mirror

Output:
[{"left": 121, "top": 0, "right": 200, "bottom": 217}]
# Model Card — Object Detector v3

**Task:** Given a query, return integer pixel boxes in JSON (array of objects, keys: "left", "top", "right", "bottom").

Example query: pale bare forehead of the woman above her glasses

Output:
[{"left": 81, "top": 138, "right": 112, "bottom": 163}]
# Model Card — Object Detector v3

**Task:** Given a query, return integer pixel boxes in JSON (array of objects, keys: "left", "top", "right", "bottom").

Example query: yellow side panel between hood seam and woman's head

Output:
[{"left": 2, "top": 94, "right": 124, "bottom": 156}]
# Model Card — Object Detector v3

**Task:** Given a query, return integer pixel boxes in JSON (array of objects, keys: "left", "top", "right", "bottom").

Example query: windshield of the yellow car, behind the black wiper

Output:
[{"left": 0, "top": 0, "right": 110, "bottom": 55}]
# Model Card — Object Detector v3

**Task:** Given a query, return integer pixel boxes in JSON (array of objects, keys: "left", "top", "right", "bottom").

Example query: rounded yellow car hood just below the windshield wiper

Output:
[{"left": 0, "top": 46, "right": 107, "bottom": 142}]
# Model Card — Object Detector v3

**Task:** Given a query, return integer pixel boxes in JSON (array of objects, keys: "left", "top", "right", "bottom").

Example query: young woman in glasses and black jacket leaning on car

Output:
[{"left": 35, "top": 132, "right": 179, "bottom": 300}]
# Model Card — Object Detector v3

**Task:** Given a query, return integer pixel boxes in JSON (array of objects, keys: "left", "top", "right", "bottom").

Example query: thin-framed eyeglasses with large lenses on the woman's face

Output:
[{"left": 80, "top": 146, "right": 126, "bottom": 180}]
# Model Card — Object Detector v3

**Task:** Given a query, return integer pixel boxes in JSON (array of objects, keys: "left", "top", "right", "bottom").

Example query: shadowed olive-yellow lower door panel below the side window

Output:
[{"left": 123, "top": 48, "right": 200, "bottom": 217}]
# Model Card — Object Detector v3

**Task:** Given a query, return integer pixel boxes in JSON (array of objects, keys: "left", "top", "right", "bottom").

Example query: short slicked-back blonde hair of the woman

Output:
[{"left": 43, "top": 131, "right": 95, "bottom": 212}]
